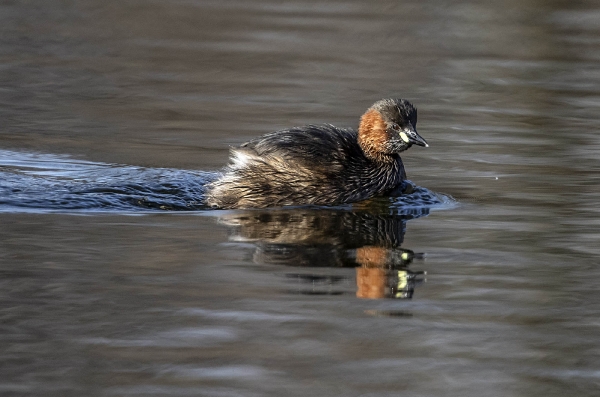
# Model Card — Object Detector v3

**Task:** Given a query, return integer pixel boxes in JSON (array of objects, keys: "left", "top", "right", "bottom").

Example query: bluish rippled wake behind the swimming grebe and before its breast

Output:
[{"left": 0, "top": 150, "right": 456, "bottom": 216}]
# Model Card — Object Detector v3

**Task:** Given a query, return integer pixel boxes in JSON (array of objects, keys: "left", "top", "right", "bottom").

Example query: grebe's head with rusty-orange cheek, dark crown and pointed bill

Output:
[{"left": 358, "top": 99, "right": 429, "bottom": 160}]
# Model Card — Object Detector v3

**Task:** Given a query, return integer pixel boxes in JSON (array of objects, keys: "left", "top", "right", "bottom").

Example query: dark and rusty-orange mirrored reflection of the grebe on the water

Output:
[{"left": 219, "top": 200, "right": 429, "bottom": 299}]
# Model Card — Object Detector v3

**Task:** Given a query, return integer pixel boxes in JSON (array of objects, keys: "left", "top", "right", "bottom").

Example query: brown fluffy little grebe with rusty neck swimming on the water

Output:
[{"left": 206, "top": 99, "right": 428, "bottom": 208}]
